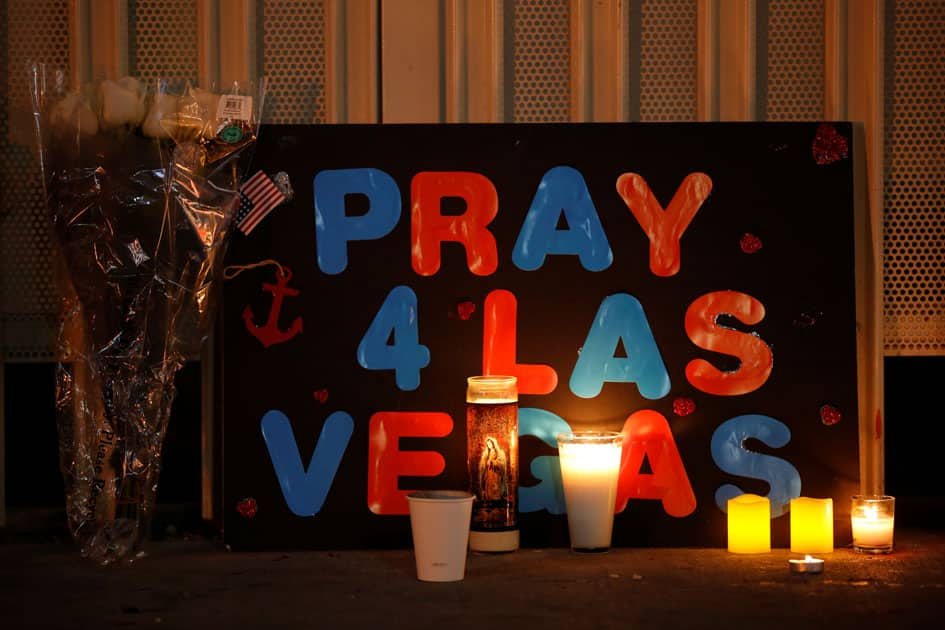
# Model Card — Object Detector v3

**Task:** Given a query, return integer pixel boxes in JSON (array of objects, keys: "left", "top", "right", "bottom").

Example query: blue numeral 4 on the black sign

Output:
[{"left": 358, "top": 286, "right": 430, "bottom": 391}]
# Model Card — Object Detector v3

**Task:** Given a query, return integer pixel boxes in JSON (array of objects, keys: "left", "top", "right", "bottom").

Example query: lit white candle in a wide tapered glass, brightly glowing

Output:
[{"left": 558, "top": 431, "right": 623, "bottom": 552}]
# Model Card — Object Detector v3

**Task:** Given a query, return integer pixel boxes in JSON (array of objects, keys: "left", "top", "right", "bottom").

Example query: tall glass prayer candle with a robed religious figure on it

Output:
[{"left": 466, "top": 376, "right": 519, "bottom": 552}]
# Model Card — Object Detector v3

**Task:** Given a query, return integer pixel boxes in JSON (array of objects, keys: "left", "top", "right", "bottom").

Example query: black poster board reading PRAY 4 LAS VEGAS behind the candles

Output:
[{"left": 219, "top": 123, "right": 859, "bottom": 549}]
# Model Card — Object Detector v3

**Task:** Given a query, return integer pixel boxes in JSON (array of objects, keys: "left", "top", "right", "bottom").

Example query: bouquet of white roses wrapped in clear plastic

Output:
[{"left": 31, "top": 65, "right": 265, "bottom": 564}]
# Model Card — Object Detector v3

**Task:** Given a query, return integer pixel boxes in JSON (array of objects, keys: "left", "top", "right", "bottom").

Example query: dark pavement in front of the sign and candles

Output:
[{"left": 0, "top": 528, "right": 945, "bottom": 630}]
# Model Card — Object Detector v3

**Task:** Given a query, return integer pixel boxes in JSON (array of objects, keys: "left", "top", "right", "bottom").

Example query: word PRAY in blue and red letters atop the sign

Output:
[{"left": 314, "top": 166, "right": 712, "bottom": 276}]
